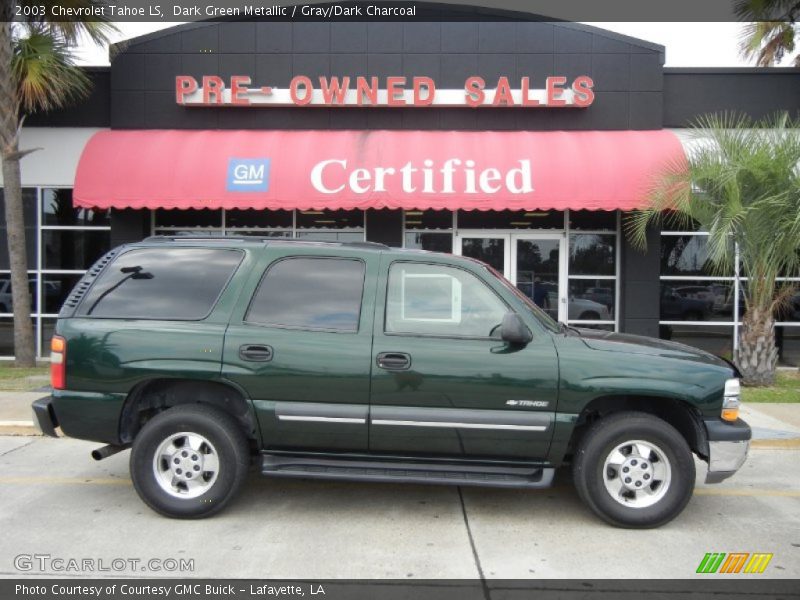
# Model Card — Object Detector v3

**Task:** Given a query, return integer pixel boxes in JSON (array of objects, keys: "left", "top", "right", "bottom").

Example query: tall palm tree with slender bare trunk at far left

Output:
[{"left": 0, "top": 5, "right": 114, "bottom": 367}]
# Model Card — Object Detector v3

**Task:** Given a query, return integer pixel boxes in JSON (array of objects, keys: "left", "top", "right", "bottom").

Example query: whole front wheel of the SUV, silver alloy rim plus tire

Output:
[{"left": 573, "top": 412, "right": 695, "bottom": 528}]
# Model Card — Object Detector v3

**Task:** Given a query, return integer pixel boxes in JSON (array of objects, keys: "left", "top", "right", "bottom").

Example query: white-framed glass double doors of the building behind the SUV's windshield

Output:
[{"left": 455, "top": 231, "right": 567, "bottom": 321}]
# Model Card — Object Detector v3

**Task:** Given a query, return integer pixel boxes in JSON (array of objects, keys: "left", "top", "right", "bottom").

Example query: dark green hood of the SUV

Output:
[{"left": 577, "top": 329, "right": 733, "bottom": 368}]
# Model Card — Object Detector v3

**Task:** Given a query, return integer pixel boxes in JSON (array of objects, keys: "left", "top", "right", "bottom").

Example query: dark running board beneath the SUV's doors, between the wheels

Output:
[{"left": 261, "top": 453, "right": 555, "bottom": 488}]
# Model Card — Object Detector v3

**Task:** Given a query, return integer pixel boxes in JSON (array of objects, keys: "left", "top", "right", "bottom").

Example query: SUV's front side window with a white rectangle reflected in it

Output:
[{"left": 385, "top": 262, "right": 508, "bottom": 338}]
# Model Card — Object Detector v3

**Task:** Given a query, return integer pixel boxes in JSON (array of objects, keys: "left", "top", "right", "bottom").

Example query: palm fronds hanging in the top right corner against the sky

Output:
[{"left": 735, "top": 0, "right": 800, "bottom": 67}]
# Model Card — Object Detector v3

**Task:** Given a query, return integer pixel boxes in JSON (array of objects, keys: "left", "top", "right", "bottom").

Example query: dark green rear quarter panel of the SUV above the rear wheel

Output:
[{"left": 53, "top": 245, "right": 255, "bottom": 443}]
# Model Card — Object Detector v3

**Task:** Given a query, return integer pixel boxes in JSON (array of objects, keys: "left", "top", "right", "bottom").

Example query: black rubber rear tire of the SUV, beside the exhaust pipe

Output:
[{"left": 130, "top": 404, "right": 250, "bottom": 519}]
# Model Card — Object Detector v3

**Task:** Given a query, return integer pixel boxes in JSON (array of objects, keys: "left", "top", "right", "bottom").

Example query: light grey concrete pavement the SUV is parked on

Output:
[{"left": 0, "top": 436, "right": 800, "bottom": 579}]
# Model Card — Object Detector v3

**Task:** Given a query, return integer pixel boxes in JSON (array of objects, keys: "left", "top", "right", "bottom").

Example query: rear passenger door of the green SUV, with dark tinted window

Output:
[{"left": 222, "top": 248, "right": 379, "bottom": 452}]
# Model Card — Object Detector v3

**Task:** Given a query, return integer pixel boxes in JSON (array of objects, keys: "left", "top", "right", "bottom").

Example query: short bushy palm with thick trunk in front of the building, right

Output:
[{"left": 626, "top": 114, "right": 800, "bottom": 385}]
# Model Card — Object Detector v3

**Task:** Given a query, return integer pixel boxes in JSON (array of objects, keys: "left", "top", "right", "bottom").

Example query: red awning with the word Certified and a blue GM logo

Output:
[{"left": 73, "top": 130, "right": 683, "bottom": 210}]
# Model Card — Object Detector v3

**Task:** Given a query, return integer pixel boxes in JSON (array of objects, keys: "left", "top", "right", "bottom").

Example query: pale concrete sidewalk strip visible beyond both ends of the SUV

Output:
[{"left": 0, "top": 391, "right": 800, "bottom": 446}]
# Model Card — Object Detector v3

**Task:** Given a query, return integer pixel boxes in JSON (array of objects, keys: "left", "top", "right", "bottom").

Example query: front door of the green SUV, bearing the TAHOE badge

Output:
[{"left": 370, "top": 261, "right": 558, "bottom": 460}]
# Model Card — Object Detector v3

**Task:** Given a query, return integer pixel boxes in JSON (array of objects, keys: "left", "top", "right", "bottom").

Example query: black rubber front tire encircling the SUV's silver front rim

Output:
[{"left": 572, "top": 412, "right": 695, "bottom": 529}]
